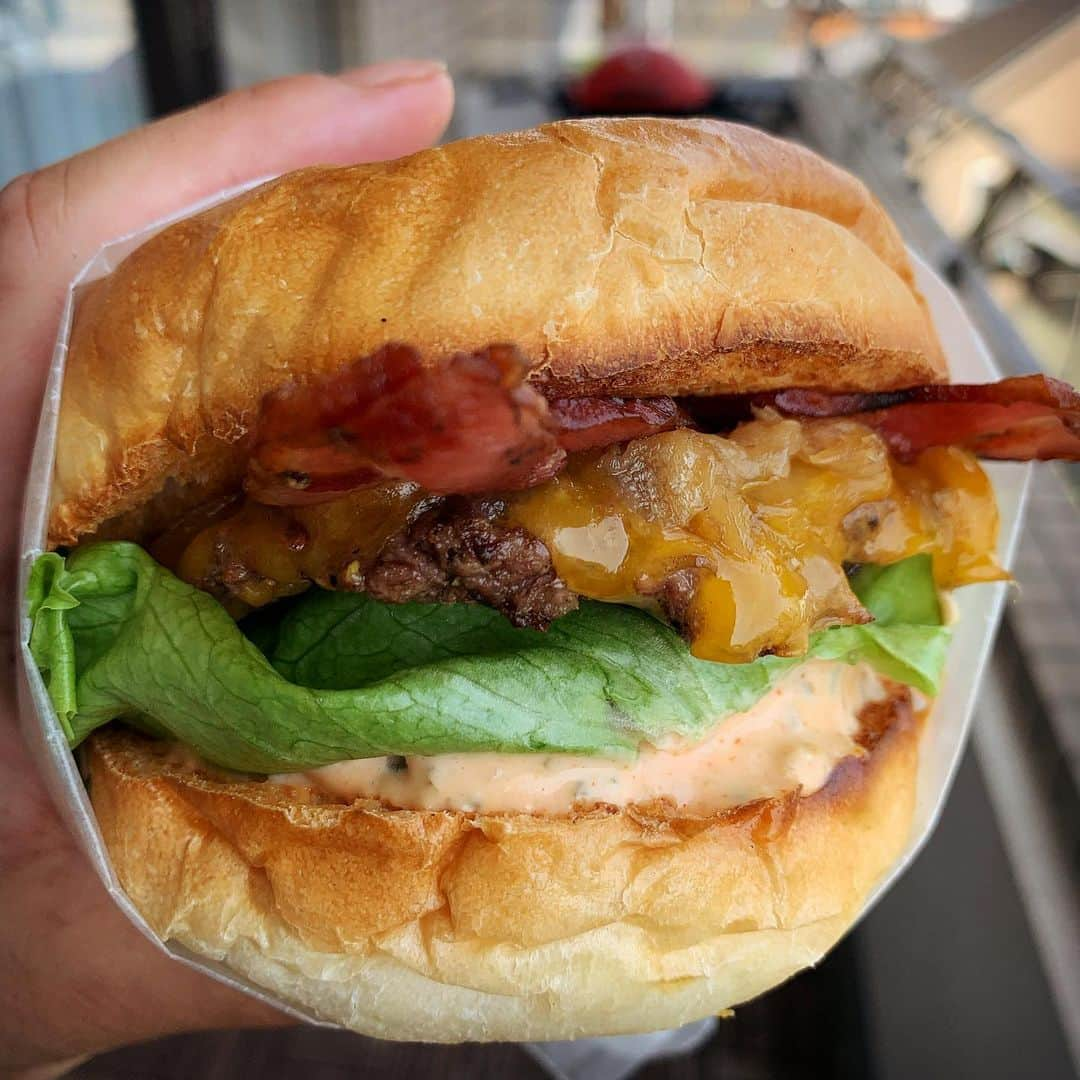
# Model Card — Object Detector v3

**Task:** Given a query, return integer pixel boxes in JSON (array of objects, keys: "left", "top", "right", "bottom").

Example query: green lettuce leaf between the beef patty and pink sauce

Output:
[{"left": 28, "top": 542, "right": 949, "bottom": 772}]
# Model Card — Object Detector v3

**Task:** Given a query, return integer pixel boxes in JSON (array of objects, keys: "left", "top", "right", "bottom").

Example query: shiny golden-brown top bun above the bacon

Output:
[{"left": 51, "top": 120, "right": 946, "bottom": 543}]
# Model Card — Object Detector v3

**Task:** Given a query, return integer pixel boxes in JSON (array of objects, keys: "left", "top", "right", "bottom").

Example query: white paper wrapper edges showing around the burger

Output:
[{"left": 16, "top": 181, "right": 1029, "bottom": 1062}]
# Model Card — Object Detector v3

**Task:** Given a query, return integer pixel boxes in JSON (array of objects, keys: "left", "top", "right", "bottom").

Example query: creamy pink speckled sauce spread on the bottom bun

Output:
[{"left": 271, "top": 660, "right": 886, "bottom": 814}]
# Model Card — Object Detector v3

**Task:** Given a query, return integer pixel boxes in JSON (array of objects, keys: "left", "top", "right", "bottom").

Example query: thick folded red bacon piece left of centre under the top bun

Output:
[{"left": 246, "top": 345, "right": 686, "bottom": 505}]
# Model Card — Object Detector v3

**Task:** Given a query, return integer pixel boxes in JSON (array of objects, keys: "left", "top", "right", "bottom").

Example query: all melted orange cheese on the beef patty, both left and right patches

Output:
[{"left": 164, "top": 413, "right": 1005, "bottom": 662}]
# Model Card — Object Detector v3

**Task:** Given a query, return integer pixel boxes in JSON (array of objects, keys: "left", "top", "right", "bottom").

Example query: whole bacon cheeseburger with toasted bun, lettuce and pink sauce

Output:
[{"left": 29, "top": 120, "right": 1080, "bottom": 1041}]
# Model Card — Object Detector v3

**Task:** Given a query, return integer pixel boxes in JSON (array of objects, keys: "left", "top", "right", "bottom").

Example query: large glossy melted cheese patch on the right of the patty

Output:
[{"left": 510, "top": 416, "right": 1003, "bottom": 662}]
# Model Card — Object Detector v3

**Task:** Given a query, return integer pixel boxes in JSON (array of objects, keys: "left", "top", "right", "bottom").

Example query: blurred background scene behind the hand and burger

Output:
[{"left": 0, "top": 0, "right": 1080, "bottom": 1080}]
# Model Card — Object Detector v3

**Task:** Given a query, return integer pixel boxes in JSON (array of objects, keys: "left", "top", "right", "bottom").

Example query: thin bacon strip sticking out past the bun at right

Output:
[{"left": 687, "top": 375, "right": 1080, "bottom": 461}]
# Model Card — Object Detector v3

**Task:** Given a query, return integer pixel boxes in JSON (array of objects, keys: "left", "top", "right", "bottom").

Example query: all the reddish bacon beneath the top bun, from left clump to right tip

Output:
[{"left": 246, "top": 345, "right": 1080, "bottom": 505}]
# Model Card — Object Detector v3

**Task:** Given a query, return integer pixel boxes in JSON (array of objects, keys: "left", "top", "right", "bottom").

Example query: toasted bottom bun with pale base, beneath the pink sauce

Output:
[{"left": 86, "top": 688, "right": 919, "bottom": 1042}]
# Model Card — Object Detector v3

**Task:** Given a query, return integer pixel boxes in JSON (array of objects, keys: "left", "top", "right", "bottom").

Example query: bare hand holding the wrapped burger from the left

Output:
[{"left": 0, "top": 62, "right": 453, "bottom": 1076}]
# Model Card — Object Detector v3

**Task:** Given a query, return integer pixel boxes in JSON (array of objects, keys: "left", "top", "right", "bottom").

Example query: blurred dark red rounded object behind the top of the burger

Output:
[{"left": 569, "top": 45, "right": 712, "bottom": 113}]
